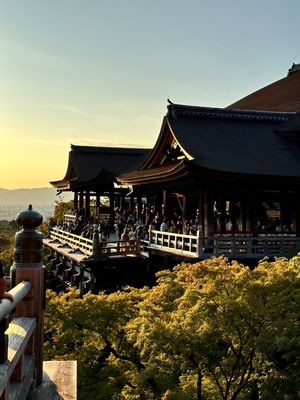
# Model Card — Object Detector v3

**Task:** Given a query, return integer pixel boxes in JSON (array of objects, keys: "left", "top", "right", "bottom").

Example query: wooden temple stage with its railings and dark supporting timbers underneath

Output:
[{"left": 44, "top": 228, "right": 300, "bottom": 293}]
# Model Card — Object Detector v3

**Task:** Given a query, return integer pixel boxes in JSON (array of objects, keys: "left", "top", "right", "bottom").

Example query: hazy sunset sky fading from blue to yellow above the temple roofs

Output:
[{"left": 0, "top": 0, "right": 300, "bottom": 188}]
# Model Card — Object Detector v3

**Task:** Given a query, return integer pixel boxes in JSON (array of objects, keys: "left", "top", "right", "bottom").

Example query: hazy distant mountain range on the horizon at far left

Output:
[{"left": 0, "top": 187, "right": 73, "bottom": 208}]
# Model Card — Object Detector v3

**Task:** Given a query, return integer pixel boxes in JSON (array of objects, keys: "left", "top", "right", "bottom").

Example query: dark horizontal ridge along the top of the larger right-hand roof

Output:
[{"left": 167, "top": 104, "right": 295, "bottom": 121}]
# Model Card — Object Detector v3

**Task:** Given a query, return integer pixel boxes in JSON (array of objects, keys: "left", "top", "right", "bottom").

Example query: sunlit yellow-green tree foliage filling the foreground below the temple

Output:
[{"left": 45, "top": 256, "right": 300, "bottom": 400}]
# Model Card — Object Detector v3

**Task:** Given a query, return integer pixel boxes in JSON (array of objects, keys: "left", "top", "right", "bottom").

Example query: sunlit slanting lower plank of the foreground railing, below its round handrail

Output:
[{"left": 0, "top": 317, "right": 36, "bottom": 394}]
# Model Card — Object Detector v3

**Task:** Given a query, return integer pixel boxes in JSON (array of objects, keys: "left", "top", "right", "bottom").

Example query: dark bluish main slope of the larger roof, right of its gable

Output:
[{"left": 167, "top": 105, "right": 300, "bottom": 177}]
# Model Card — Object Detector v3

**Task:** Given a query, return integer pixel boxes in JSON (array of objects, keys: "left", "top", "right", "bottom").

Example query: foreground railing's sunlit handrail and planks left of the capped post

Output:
[{"left": 0, "top": 281, "right": 37, "bottom": 400}]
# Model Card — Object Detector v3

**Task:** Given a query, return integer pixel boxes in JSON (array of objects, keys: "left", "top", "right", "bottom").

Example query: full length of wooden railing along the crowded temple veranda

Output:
[{"left": 50, "top": 228, "right": 300, "bottom": 259}]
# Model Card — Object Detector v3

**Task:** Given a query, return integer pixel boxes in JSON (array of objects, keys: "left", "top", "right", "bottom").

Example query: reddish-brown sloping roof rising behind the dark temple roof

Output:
[{"left": 227, "top": 64, "right": 300, "bottom": 112}]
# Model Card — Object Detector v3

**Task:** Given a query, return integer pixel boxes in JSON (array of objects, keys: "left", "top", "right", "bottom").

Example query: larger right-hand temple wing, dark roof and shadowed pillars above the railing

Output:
[{"left": 118, "top": 104, "right": 300, "bottom": 237}]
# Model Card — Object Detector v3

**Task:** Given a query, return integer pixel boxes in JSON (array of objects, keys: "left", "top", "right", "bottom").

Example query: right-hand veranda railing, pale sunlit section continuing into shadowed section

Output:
[{"left": 148, "top": 230, "right": 300, "bottom": 259}]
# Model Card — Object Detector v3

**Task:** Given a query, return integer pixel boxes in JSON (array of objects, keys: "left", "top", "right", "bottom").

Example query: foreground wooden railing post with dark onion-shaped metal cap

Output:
[{"left": 10, "top": 205, "right": 45, "bottom": 385}]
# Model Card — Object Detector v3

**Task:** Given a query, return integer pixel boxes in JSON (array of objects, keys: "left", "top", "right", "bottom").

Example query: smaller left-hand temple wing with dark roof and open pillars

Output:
[{"left": 50, "top": 145, "right": 149, "bottom": 219}]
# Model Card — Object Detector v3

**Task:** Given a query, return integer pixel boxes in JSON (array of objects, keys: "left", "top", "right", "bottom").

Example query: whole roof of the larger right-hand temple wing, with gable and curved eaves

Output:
[{"left": 121, "top": 104, "right": 300, "bottom": 185}]
